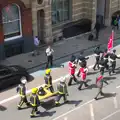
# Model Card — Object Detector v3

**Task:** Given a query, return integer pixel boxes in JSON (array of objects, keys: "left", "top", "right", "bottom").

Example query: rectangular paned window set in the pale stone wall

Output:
[{"left": 51, "top": 0, "right": 70, "bottom": 25}]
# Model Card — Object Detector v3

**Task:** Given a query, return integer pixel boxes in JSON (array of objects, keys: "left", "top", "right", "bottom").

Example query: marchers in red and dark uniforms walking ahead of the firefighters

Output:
[{"left": 68, "top": 46, "right": 120, "bottom": 100}]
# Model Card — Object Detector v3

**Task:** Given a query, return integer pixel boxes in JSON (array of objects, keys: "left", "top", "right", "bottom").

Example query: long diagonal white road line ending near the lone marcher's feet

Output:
[{"left": 53, "top": 99, "right": 94, "bottom": 120}]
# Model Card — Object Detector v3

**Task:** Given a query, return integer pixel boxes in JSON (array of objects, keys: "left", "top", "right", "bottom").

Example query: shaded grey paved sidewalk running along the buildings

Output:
[{"left": 1, "top": 27, "right": 120, "bottom": 71}]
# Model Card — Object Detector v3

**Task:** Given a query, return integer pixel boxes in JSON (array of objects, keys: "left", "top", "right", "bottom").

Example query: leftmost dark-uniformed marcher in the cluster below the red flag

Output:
[{"left": 93, "top": 46, "right": 103, "bottom": 70}]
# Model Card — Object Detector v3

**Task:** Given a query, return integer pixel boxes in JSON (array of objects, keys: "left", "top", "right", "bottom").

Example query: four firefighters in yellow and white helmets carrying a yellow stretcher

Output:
[{"left": 16, "top": 69, "right": 68, "bottom": 118}]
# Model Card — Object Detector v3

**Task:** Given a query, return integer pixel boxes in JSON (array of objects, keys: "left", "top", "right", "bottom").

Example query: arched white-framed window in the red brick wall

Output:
[{"left": 2, "top": 4, "right": 22, "bottom": 41}]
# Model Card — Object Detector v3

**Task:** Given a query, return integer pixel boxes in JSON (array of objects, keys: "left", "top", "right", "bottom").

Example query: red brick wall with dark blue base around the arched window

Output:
[{"left": 0, "top": 0, "right": 33, "bottom": 59}]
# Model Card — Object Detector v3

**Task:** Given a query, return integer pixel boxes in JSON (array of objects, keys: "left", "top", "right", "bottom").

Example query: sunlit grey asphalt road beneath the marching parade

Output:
[{"left": 0, "top": 48, "right": 120, "bottom": 120}]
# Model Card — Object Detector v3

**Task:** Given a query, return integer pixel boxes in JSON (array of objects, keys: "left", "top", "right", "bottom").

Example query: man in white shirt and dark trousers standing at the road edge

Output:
[{"left": 46, "top": 46, "right": 54, "bottom": 68}]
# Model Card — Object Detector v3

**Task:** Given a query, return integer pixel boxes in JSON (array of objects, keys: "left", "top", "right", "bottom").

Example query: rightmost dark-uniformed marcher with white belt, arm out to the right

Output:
[{"left": 109, "top": 50, "right": 120, "bottom": 75}]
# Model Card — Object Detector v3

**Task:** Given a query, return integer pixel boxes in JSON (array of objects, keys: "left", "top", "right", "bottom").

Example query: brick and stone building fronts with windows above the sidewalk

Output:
[{"left": 0, "top": 0, "right": 120, "bottom": 59}]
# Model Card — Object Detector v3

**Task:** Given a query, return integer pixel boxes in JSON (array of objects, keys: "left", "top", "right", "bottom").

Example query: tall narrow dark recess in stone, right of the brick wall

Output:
[{"left": 37, "top": 9, "right": 45, "bottom": 43}]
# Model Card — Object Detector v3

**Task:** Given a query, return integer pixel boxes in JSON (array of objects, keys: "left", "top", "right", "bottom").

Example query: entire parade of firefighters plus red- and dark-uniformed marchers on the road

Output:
[{"left": 17, "top": 46, "right": 120, "bottom": 117}]
